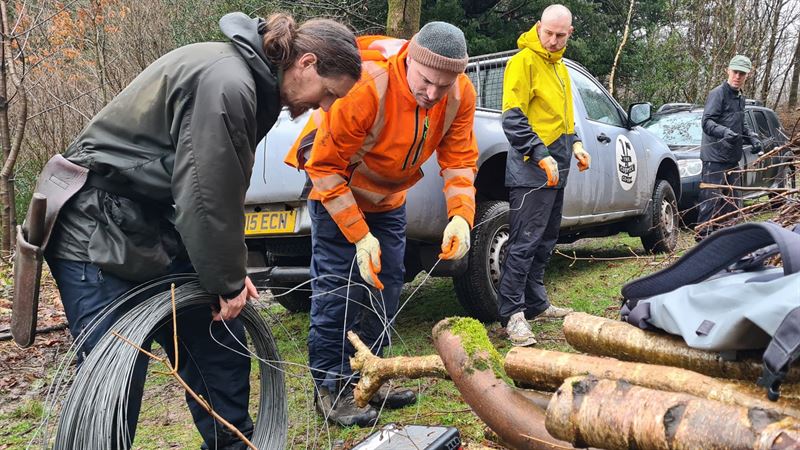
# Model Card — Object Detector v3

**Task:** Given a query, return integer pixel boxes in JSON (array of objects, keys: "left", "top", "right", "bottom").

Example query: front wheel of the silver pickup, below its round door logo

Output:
[{"left": 642, "top": 180, "right": 679, "bottom": 253}]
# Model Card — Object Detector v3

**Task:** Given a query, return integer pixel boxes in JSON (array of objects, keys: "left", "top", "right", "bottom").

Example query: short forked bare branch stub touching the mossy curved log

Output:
[{"left": 347, "top": 331, "right": 450, "bottom": 408}]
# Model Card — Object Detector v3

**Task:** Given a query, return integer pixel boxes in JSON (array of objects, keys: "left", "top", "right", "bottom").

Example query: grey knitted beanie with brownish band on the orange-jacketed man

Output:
[{"left": 408, "top": 22, "right": 469, "bottom": 73}]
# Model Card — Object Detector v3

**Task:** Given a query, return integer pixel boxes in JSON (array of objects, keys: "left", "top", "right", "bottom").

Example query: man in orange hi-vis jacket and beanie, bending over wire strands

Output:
[{"left": 287, "top": 22, "right": 478, "bottom": 426}]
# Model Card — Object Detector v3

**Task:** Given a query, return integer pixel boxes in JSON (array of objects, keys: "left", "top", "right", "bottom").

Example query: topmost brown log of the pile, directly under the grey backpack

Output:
[{"left": 564, "top": 313, "right": 800, "bottom": 383}]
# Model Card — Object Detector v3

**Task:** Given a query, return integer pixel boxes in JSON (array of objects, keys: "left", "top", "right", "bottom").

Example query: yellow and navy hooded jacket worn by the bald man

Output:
[{"left": 503, "top": 24, "right": 579, "bottom": 188}]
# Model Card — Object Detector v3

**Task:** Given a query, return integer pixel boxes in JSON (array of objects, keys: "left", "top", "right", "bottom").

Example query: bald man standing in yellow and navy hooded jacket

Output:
[{"left": 499, "top": 5, "right": 590, "bottom": 346}]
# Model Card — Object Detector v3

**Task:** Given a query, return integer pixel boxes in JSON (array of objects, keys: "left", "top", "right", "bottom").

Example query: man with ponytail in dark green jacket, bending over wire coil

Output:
[{"left": 40, "top": 13, "right": 361, "bottom": 449}]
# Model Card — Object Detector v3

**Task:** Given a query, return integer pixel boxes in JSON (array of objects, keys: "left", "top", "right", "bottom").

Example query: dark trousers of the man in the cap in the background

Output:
[{"left": 697, "top": 161, "right": 741, "bottom": 234}]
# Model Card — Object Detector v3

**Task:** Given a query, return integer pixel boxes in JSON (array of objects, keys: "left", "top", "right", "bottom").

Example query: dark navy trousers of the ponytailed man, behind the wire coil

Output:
[{"left": 47, "top": 258, "right": 253, "bottom": 450}]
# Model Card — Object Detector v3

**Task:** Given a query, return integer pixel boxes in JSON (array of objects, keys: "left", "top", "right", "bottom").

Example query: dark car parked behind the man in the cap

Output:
[{"left": 642, "top": 100, "right": 795, "bottom": 223}]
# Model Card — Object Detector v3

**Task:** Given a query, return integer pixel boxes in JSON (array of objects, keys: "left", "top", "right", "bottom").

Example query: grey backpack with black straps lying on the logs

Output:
[{"left": 621, "top": 222, "right": 800, "bottom": 400}]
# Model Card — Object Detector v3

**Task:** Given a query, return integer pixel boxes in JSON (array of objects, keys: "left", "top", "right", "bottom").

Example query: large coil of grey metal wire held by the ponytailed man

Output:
[{"left": 50, "top": 275, "right": 288, "bottom": 450}]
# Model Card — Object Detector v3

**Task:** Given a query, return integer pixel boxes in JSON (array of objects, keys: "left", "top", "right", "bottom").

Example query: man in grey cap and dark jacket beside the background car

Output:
[{"left": 696, "top": 55, "right": 762, "bottom": 241}]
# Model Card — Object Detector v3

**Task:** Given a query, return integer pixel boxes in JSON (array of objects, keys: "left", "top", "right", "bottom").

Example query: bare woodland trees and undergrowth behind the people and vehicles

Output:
[{"left": 0, "top": 0, "right": 800, "bottom": 256}]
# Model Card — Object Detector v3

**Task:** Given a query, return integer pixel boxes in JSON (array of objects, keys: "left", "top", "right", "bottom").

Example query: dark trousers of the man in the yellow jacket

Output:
[{"left": 499, "top": 188, "right": 564, "bottom": 322}]
